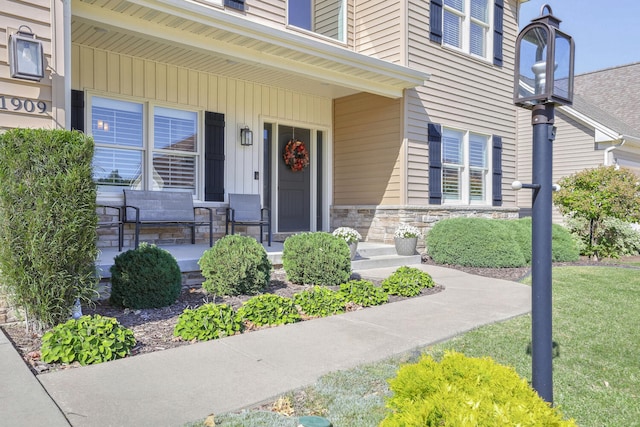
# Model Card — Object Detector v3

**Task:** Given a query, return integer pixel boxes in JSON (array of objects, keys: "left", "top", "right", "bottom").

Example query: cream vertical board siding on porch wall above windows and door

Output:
[{"left": 72, "top": 45, "right": 332, "bottom": 197}]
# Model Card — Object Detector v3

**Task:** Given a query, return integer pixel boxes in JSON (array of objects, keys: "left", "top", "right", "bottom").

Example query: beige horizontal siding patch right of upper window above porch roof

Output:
[{"left": 355, "top": 0, "right": 405, "bottom": 63}]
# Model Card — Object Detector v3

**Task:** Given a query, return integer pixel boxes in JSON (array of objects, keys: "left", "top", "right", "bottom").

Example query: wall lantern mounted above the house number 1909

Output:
[{"left": 9, "top": 25, "right": 44, "bottom": 81}]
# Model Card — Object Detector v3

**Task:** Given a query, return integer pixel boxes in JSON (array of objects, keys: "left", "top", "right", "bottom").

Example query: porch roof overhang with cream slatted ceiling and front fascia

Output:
[{"left": 71, "top": 0, "right": 429, "bottom": 98}]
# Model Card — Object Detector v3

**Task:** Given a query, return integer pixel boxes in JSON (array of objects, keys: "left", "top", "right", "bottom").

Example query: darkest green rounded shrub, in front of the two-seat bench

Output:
[{"left": 109, "top": 242, "right": 182, "bottom": 308}]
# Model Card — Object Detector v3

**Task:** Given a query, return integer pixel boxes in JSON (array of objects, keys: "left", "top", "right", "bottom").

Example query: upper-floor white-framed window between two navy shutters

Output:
[{"left": 442, "top": 0, "right": 493, "bottom": 59}]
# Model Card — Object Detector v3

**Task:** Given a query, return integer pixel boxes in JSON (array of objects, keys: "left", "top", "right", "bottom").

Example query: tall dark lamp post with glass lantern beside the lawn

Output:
[{"left": 513, "top": 5, "right": 574, "bottom": 403}]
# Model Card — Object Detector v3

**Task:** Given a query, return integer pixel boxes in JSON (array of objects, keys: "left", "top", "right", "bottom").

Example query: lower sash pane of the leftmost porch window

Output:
[{"left": 93, "top": 147, "right": 142, "bottom": 191}]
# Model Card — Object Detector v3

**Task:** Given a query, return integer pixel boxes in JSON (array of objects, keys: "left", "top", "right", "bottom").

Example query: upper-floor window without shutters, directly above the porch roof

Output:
[{"left": 287, "top": 0, "right": 347, "bottom": 43}]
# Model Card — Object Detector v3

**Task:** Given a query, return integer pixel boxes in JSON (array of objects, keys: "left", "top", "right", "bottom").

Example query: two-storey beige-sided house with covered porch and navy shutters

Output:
[{"left": 0, "top": 0, "right": 519, "bottom": 247}]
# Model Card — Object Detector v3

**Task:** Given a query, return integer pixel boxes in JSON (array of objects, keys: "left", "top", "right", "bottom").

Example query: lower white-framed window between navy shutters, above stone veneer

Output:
[{"left": 442, "top": 128, "right": 491, "bottom": 204}]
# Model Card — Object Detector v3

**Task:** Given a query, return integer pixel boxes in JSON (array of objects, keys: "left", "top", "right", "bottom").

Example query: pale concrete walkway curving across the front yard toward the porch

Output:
[{"left": 0, "top": 265, "right": 531, "bottom": 427}]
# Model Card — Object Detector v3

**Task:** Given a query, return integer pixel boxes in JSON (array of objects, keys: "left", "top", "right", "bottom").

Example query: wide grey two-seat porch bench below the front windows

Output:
[{"left": 122, "top": 190, "right": 213, "bottom": 249}]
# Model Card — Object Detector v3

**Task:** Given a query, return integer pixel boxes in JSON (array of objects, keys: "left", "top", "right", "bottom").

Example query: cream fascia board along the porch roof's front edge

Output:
[{"left": 119, "top": 0, "right": 430, "bottom": 89}]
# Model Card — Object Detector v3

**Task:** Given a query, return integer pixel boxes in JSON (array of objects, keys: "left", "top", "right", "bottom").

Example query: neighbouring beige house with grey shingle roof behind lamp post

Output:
[{"left": 517, "top": 63, "right": 640, "bottom": 222}]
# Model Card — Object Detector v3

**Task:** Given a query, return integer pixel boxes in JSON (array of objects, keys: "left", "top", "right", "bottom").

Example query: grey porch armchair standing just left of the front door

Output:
[{"left": 225, "top": 194, "right": 271, "bottom": 246}]
